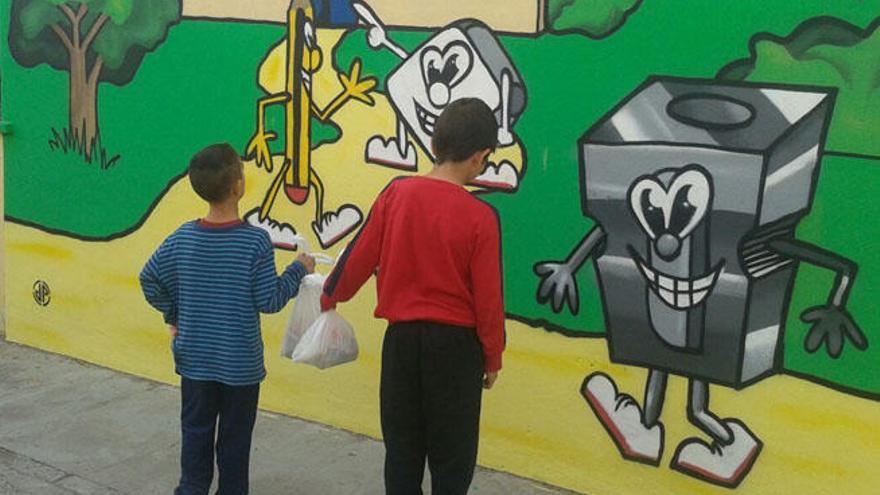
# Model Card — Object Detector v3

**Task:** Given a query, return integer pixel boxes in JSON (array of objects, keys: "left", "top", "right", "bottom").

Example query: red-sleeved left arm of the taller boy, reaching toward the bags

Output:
[{"left": 321, "top": 189, "right": 387, "bottom": 311}]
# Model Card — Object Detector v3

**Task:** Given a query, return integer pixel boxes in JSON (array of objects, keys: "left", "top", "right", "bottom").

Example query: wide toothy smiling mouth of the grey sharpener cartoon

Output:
[{"left": 629, "top": 246, "right": 725, "bottom": 310}]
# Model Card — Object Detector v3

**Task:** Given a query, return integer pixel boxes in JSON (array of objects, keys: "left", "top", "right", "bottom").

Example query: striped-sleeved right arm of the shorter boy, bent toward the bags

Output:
[{"left": 253, "top": 237, "right": 308, "bottom": 313}]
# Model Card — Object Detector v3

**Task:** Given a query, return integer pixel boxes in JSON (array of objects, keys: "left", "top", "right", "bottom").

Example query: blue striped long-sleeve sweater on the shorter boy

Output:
[{"left": 140, "top": 222, "right": 306, "bottom": 385}]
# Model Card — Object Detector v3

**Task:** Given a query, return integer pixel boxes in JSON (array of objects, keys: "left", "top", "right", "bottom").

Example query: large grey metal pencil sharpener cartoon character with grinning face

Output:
[{"left": 534, "top": 77, "right": 868, "bottom": 488}]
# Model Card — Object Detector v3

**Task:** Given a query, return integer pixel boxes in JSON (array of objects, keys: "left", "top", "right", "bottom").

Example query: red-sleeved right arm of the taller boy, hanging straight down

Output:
[{"left": 470, "top": 211, "right": 506, "bottom": 373}]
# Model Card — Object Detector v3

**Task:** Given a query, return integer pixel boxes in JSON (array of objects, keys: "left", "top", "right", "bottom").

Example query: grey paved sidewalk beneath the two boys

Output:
[{"left": 0, "top": 335, "right": 570, "bottom": 495}]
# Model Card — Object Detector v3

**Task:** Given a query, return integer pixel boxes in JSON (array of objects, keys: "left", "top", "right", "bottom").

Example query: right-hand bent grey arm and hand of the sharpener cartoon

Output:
[{"left": 769, "top": 239, "right": 868, "bottom": 358}]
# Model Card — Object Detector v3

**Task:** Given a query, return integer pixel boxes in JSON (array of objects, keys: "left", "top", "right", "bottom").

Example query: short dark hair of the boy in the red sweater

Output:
[{"left": 433, "top": 98, "right": 498, "bottom": 163}]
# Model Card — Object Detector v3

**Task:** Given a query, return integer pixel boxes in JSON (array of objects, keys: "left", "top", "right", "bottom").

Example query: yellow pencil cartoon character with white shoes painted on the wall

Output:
[{"left": 245, "top": 0, "right": 376, "bottom": 249}]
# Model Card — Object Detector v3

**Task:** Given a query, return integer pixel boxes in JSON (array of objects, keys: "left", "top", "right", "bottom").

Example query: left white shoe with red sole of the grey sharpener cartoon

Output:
[{"left": 581, "top": 372, "right": 663, "bottom": 466}]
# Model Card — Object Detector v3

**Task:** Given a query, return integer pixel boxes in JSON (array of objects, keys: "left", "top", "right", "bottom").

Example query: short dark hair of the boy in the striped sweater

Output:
[{"left": 189, "top": 143, "right": 242, "bottom": 203}]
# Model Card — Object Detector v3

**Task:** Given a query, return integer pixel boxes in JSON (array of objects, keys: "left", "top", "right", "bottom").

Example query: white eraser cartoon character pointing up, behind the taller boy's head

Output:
[{"left": 352, "top": 2, "right": 526, "bottom": 190}]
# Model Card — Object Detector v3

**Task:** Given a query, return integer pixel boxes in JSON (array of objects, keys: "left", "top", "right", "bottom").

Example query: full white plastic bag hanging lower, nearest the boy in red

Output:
[{"left": 292, "top": 309, "right": 358, "bottom": 369}]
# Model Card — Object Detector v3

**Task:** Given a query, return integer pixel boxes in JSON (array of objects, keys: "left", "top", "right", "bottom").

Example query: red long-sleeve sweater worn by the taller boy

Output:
[{"left": 321, "top": 177, "right": 505, "bottom": 372}]
